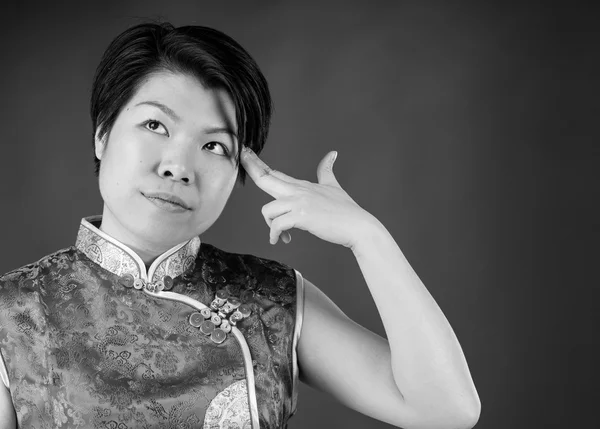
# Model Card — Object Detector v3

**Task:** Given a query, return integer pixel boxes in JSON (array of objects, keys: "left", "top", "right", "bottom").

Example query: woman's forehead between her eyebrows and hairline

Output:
[{"left": 128, "top": 71, "right": 237, "bottom": 130}]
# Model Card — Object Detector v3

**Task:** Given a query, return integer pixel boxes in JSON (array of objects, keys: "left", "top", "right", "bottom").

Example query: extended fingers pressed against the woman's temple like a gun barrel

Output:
[{"left": 240, "top": 146, "right": 297, "bottom": 198}]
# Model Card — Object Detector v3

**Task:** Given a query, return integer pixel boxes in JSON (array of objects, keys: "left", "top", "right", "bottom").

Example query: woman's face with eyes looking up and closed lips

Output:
[{"left": 96, "top": 71, "right": 238, "bottom": 248}]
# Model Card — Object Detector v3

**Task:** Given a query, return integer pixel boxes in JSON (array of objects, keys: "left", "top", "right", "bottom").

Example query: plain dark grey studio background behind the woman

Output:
[{"left": 0, "top": 1, "right": 600, "bottom": 429}]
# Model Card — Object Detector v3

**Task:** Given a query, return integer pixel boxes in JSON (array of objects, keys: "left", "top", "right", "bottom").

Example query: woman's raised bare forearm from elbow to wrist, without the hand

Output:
[{"left": 351, "top": 218, "right": 480, "bottom": 419}]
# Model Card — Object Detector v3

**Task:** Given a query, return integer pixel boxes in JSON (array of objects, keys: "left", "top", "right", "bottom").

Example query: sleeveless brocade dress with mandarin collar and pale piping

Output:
[{"left": 0, "top": 216, "right": 304, "bottom": 429}]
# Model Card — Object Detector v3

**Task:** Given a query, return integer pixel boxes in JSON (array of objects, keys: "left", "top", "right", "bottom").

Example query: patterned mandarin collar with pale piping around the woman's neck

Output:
[{"left": 75, "top": 215, "right": 200, "bottom": 282}]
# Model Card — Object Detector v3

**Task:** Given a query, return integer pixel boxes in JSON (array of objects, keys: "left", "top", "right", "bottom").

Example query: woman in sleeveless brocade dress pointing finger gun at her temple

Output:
[{"left": 0, "top": 24, "right": 480, "bottom": 428}]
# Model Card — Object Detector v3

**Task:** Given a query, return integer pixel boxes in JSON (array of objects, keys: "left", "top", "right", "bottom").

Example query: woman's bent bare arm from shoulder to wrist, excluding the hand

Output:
[{"left": 298, "top": 217, "right": 481, "bottom": 429}]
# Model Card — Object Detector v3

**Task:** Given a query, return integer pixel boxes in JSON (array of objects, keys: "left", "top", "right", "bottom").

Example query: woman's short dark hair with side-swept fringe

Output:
[{"left": 90, "top": 22, "right": 273, "bottom": 183}]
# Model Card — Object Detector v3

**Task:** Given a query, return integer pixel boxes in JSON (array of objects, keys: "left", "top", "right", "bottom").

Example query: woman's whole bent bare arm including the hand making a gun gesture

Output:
[{"left": 241, "top": 149, "right": 480, "bottom": 429}]
